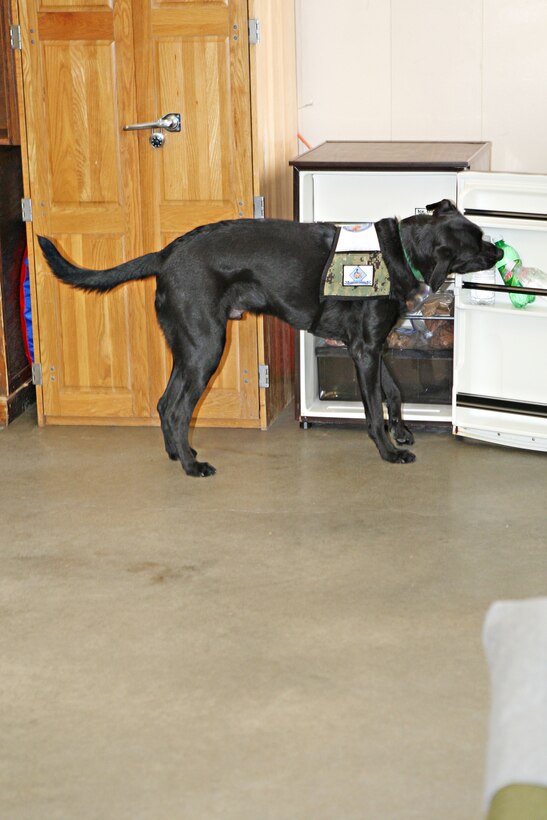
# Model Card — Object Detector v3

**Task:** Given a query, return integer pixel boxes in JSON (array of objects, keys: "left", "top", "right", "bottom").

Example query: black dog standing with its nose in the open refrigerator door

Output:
[{"left": 38, "top": 200, "right": 502, "bottom": 476}]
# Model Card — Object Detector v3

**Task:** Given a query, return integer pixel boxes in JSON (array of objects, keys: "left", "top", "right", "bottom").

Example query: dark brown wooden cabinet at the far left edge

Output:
[{"left": 0, "top": 0, "right": 34, "bottom": 426}]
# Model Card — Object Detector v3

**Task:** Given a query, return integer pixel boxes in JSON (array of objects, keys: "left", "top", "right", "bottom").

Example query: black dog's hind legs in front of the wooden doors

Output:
[{"left": 158, "top": 327, "right": 225, "bottom": 476}]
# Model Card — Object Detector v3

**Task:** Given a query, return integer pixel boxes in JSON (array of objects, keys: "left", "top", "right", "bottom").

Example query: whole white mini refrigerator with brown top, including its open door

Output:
[{"left": 291, "top": 142, "right": 547, "bottom": 450}]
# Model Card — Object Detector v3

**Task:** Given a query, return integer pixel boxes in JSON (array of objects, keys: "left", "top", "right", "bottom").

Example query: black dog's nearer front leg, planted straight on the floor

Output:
[{"left": 349, "top": 340, "right": 416, "bottom": 464}]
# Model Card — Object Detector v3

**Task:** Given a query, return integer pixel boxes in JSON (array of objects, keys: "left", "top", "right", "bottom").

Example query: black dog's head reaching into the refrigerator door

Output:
[{"left": 400, "top": 199, "right": 503, "bottom": 291}]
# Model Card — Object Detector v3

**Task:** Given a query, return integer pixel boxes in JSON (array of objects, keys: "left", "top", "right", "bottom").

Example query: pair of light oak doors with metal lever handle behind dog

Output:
[{"left": 15, "top": 0, "right": 258, "bottom": 423}]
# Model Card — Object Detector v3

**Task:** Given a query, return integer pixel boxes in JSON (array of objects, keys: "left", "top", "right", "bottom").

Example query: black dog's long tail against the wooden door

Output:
[{"left": 38, "top": 236, "right": 161, "bottom": 293}]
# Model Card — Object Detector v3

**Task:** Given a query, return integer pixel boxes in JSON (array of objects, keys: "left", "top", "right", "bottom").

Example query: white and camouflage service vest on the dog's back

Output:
[{"left": 320, "top": 222, "right": 391, "bottom": 299}]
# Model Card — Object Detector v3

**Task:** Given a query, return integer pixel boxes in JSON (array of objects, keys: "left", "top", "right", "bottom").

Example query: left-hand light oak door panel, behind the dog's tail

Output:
[{"left": 20, "top": 0, "right": 150, "bottom": 419}]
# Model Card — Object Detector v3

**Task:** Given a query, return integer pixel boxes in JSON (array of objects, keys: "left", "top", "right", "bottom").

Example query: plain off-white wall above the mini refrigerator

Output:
[{"left": 297, "top": 0, "right": 547, "bottom": 173}]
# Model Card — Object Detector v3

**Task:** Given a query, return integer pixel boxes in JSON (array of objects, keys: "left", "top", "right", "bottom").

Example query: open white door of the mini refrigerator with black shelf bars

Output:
[{"left": 452, "top": 171, "right": 547, "bottom": 451}]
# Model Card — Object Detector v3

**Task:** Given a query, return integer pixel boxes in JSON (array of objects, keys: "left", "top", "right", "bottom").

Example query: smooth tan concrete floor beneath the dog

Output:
[{"left": 0, "top": 410, "right": 547, "bottom": 820}]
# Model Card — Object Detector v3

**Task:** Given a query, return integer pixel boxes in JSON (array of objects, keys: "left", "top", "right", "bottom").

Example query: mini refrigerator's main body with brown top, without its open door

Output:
[{"left": 290, "top": 141, "right": 490, "bottom": 429}]
